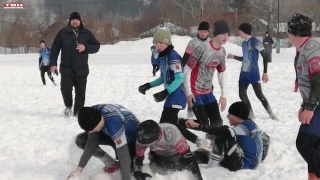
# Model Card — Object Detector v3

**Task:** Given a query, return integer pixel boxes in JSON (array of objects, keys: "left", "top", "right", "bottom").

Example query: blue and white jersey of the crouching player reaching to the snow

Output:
[{"left": 92, "top": 104, "right": 139, "bottom": 148}]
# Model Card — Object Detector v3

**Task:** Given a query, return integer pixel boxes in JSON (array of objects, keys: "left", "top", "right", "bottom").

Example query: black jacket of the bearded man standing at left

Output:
[{"left": 50, "top": 22, "right": 100, "bottom": 76}]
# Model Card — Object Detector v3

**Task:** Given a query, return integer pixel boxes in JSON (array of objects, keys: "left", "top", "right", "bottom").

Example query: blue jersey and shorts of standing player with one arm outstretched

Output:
[{"left": 239, "top": 37, "right": 264, "bottom": 84}]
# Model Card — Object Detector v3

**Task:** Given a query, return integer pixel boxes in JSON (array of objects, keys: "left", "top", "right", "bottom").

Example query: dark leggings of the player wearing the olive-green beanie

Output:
[{"left": 160, "top": 108, "right": 197, "bottom": 143}]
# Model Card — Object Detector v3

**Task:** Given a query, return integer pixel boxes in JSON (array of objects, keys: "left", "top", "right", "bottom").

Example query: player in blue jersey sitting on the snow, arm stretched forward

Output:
[{"left": 185, "top": 102, "right": 269, "bottom": 171}]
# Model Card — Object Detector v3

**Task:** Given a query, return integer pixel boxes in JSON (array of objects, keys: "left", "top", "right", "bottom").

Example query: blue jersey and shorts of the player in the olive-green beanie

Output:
[{"left": 158, "top": 50, "right": 187, "bottom": 109}]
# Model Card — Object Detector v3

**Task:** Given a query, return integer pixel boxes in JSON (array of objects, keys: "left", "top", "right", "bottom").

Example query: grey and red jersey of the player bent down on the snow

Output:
[{"left": 136, "top": 123, "right": 189, "bottom": 158}]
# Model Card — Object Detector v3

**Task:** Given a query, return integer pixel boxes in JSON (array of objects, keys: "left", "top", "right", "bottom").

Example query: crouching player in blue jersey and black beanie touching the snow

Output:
[{"left": 68, "top": 104, "right": 139, "bottom": 180}]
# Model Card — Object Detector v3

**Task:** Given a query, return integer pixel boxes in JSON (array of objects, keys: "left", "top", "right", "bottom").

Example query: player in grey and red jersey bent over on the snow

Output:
[{"left": 134, "top": 120, "right": 202, "bottom": 180}]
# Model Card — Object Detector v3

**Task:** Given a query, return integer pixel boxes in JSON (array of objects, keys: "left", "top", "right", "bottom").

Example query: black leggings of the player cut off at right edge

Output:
[{"left": 296, "top": 132, "right": 320, "bottom": 178}]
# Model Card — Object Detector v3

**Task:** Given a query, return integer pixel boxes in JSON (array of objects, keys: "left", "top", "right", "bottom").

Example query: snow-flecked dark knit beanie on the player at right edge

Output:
[{"left": 288, "top": 13, "right": 312, "bottom": 37}]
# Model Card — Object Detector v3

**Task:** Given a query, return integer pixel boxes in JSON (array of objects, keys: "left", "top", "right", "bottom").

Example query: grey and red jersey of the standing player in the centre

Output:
[{"left": 187, "top": 40, "right": 226, "bottom": 95}]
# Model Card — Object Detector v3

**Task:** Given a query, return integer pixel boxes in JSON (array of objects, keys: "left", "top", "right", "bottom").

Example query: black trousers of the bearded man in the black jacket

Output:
[{"left": 61, "top": 75, "right": 87, "bottom": 115}]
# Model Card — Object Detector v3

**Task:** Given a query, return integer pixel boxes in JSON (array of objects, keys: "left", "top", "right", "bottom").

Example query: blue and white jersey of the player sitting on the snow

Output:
[{"left": 230, "top": 119, "right": 263, "bottom": 169}]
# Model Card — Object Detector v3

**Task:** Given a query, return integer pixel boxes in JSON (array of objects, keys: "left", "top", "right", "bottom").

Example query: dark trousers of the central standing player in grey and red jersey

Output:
[{"left": 192, "top": 101, "right": 222, "bottom": 127}]
